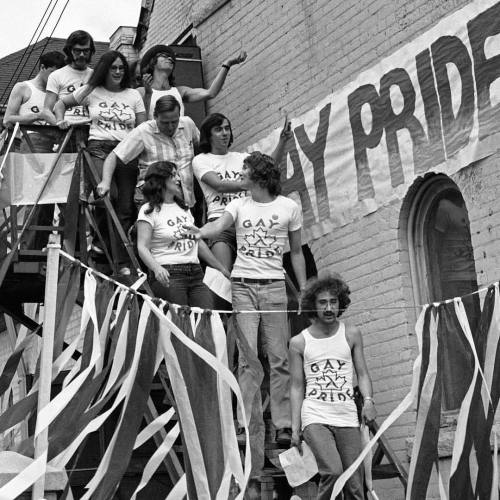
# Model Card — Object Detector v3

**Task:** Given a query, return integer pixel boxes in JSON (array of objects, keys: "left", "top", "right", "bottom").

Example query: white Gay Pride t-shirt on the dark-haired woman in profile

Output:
[{"left": 137, "top": 203, "right": 200, "bottom": 266}]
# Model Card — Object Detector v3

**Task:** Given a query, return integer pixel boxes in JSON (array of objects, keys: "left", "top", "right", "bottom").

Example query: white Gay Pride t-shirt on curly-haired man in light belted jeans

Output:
[{"left": 226, "top": 196, "right": 302, "bottom": 279}]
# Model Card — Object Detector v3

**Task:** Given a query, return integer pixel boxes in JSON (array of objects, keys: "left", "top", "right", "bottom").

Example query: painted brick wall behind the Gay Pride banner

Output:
[{"left": 148, "top": 0, "right": 500, "bottom": 499}]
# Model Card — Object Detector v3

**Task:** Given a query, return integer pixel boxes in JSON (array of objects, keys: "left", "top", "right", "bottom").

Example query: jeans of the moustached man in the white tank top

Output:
[{"left": 303, "top": 424, "right": 365, "bottom": 500}]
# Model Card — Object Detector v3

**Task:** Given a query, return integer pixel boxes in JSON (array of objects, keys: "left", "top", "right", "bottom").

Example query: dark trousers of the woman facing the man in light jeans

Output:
[{"left": 151, "top": 264, "right": 213, "bottom": 309}]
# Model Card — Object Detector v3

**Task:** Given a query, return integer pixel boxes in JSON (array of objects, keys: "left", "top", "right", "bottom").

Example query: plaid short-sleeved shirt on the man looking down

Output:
[{"left": 114, "top": 116, "right": 200, "bottom": 207}]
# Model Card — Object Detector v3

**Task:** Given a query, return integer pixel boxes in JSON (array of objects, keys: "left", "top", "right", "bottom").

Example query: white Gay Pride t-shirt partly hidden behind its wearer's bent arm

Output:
[{"left": 193, "top": 151, "right": 248, "bottom": 219}]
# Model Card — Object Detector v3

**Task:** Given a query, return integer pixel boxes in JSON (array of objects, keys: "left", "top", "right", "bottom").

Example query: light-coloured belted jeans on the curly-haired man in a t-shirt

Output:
[{"left": 232, "top": 280, "right": 291, "bottom": 429}]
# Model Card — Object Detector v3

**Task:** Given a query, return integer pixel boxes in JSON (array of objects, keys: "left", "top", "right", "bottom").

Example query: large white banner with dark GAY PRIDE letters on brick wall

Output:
[{"left": 254, "top": 0, "right": 500, "bottom": 240}]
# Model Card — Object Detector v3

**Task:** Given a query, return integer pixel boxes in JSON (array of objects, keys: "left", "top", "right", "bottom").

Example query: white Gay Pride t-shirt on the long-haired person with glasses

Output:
[{"left": 73, "top": 87, "right": 146, "bottom": 141}]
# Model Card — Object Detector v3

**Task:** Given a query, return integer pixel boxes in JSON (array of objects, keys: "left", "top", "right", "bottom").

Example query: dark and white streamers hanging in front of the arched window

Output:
[{"left": 332, "top": 290, "right": 500, "bottom": 500}]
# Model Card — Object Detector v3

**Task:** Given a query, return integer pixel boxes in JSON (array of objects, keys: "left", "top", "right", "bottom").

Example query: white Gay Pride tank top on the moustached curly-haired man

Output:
[{"left": 301, "top": 322, "right": 359, "bottom": 429}]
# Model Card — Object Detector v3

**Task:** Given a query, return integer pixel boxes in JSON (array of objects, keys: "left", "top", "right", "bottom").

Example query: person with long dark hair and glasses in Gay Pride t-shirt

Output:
[{"left": 54, "top": 50, "right": 146, "bottom": 274}]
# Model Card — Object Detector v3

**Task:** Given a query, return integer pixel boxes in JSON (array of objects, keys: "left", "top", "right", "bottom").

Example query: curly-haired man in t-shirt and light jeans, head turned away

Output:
[{"left": 185, "top": 151, "right": 306, "bottom": 460}]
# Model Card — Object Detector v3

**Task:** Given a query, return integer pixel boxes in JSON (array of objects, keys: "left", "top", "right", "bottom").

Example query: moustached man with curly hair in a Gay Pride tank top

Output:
[{"left": 290, "top": 275, "right": 376, "bottom": 500}]
